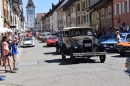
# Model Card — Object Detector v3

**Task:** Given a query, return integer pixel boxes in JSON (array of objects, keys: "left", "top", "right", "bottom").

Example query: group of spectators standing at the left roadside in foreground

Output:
[{"left": 0, "top": 32, "right": 22, "bottom": 73}]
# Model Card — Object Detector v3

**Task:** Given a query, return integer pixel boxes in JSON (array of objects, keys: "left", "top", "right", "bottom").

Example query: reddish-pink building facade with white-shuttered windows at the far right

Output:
[{"left": 113, "top": 0, "right": 130, "bottom": 30}]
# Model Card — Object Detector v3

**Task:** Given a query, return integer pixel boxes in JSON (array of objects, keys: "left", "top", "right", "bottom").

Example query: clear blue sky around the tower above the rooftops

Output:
[{"left": 23, "top": 0, "right": 59, "bottom": 19}]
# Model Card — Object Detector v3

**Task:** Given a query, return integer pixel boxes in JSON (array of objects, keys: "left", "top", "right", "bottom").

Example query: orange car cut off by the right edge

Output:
[{"left": 117, "top": 35, "right": 130, "bottom": 56}]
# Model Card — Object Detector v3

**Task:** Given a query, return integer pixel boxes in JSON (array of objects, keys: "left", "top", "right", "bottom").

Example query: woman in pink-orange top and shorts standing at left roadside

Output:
[{"left": 2, "top": 36, "right": 16, "bottom": 73}]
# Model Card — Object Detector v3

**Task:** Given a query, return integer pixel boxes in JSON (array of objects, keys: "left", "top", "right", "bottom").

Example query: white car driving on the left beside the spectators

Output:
[{"left": 21, "top": 38, "right": 35, "bottom": 47}]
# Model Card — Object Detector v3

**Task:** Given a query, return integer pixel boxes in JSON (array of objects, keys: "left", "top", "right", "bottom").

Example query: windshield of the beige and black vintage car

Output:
[{"left": 70, "top": 28, "right": 92, "bottom": 36}]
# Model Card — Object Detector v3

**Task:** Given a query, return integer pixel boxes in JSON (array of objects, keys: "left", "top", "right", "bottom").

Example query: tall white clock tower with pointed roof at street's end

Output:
[{"left": 26, "top": 0, "right": 35, "bottom": 29}]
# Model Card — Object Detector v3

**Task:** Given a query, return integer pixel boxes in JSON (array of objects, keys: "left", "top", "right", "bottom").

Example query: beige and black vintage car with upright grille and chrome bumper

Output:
[{"left": 61, "top": 26, "right": 106, "bottom": 63}]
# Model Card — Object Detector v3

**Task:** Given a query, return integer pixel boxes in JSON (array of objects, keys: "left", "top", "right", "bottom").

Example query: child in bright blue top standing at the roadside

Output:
[{"left": 11, "top": 39, "right": 18, "bottom": 70}]
